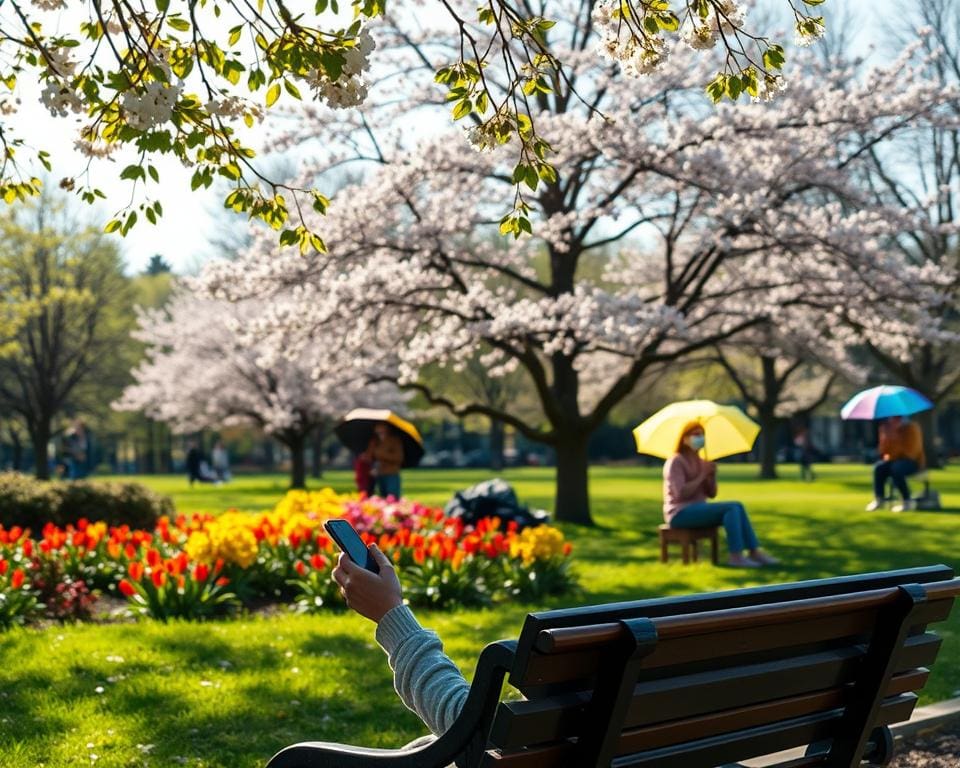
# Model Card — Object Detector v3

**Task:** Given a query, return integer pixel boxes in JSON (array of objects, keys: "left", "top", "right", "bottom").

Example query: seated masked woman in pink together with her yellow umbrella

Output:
[{"left": 633, "top": 400, "right": 779, "bottom": 568}]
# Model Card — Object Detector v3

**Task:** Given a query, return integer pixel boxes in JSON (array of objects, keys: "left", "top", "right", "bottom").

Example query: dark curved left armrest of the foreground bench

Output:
[{"left": 266, "top": 640, "right": 517, "bottom": 768}]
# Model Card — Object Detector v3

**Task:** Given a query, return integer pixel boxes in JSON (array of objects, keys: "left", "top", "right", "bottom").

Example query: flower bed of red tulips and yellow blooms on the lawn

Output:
[{"left": 0, "top": 489, "right": 576, "bottom": 629}]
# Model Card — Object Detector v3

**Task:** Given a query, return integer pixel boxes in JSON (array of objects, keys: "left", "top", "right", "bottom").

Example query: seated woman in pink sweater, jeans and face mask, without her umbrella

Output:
[{"left": 663, "top": 422, "right": 778, "bottom": 568}]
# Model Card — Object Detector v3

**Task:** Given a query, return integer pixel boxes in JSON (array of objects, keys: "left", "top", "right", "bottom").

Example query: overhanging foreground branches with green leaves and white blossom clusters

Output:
[{"left": 0, "top": 0, "right": 825, "bottom": 250}]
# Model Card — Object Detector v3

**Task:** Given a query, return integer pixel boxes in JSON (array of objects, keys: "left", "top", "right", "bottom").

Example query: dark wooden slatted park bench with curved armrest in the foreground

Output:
[{"left": 269, "top": 566, "right": 960, "bottom": 768}]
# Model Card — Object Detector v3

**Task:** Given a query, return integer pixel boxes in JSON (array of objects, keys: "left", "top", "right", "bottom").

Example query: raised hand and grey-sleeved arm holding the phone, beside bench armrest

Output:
[{"left": 333, "top": 544, "right": 470, "bottom": 760}]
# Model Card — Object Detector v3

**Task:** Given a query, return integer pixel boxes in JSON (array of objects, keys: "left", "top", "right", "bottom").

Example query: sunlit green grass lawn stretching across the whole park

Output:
[{"left": 0, "top": 464, "right": 960, "bottom": 768}]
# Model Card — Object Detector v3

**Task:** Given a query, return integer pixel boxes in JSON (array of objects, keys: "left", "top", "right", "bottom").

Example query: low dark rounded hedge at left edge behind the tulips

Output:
[{"left": 0, "top": 472, "right": 173, "bottom": 531}]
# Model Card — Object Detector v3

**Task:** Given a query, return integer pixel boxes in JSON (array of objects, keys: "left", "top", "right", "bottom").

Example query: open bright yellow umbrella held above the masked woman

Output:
[{"left": 633, "top": 400, "right": 760, "bottom": 461}]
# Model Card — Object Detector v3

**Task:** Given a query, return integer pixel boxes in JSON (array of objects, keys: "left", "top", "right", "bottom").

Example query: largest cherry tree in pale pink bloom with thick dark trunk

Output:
[{"left": 205, "top": 28, "right": 950, "bottom": 523}]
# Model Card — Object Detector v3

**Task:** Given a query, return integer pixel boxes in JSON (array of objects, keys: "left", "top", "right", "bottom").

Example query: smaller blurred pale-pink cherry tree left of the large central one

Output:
[{"left": 114, "top": 287, "right": 396, "bottom": 488}]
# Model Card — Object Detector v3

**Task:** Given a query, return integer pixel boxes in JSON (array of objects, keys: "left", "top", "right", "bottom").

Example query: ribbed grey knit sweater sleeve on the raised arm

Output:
[{"left": 377, "top": 605, "right": 470, "bottom": 736}]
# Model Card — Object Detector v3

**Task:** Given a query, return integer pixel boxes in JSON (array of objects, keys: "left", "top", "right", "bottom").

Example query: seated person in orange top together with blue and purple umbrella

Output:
[{"left": 840, "top": 385, "right": 933, "bottom": 512}]
